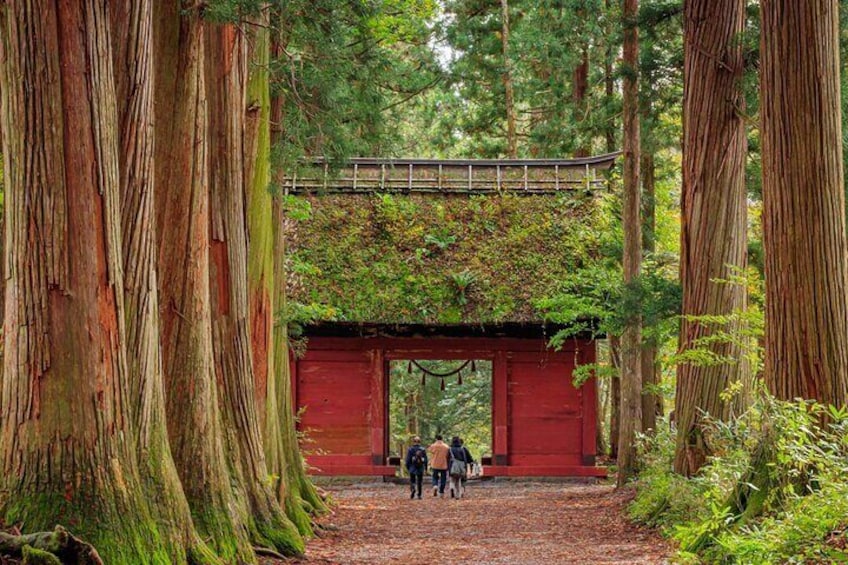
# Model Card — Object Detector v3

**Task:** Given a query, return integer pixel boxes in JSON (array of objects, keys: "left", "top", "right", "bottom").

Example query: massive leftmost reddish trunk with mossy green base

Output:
[{"left": 0, "top": 1, "right": 169, "bottom": 563}]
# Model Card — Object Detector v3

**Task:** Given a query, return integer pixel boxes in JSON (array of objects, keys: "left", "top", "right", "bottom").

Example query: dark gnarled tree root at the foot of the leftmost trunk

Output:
[{"left": 0, "top": 526, "right": 103, "bottom": 565}]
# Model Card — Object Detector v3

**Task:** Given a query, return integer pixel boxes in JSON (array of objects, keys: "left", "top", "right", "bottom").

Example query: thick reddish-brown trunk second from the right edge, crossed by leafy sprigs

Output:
[{"left": 674, "top": 0, "right": 747, "bottom": 476}]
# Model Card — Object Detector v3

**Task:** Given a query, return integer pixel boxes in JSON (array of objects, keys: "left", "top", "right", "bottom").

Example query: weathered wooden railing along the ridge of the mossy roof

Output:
[{"left": 283, "top": 153, "right": 620, "bottom": 195}]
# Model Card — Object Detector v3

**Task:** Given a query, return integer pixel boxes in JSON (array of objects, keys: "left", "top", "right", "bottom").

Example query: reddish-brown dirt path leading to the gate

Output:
[{"left": 284, "top": 481, "right": 669, "bottom": 565}]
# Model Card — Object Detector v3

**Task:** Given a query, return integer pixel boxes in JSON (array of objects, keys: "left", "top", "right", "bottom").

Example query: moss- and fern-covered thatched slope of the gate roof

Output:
[{"left": 287, "top": 191, "right": 609, "bottom": 324}]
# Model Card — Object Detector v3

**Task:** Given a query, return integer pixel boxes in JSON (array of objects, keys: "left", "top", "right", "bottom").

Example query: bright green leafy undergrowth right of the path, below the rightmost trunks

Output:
[{"left": 630, "top": 394, "right": 848, "bottom": 564}]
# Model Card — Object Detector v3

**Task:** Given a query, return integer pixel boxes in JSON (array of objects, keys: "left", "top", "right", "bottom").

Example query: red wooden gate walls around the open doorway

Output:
[{"left": 292, "top": 328, "right": 605, "bottom": 476}]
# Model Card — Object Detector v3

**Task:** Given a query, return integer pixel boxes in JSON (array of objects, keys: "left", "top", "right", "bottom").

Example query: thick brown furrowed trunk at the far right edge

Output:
[{"left": 760, "top": 0, "right": 848, "bottom": 406}]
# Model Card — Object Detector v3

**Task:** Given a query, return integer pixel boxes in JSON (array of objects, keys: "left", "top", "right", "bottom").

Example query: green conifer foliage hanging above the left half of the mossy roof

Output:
[{"left": 271, "top": 0, "right": 441, "bottom": 167}]
